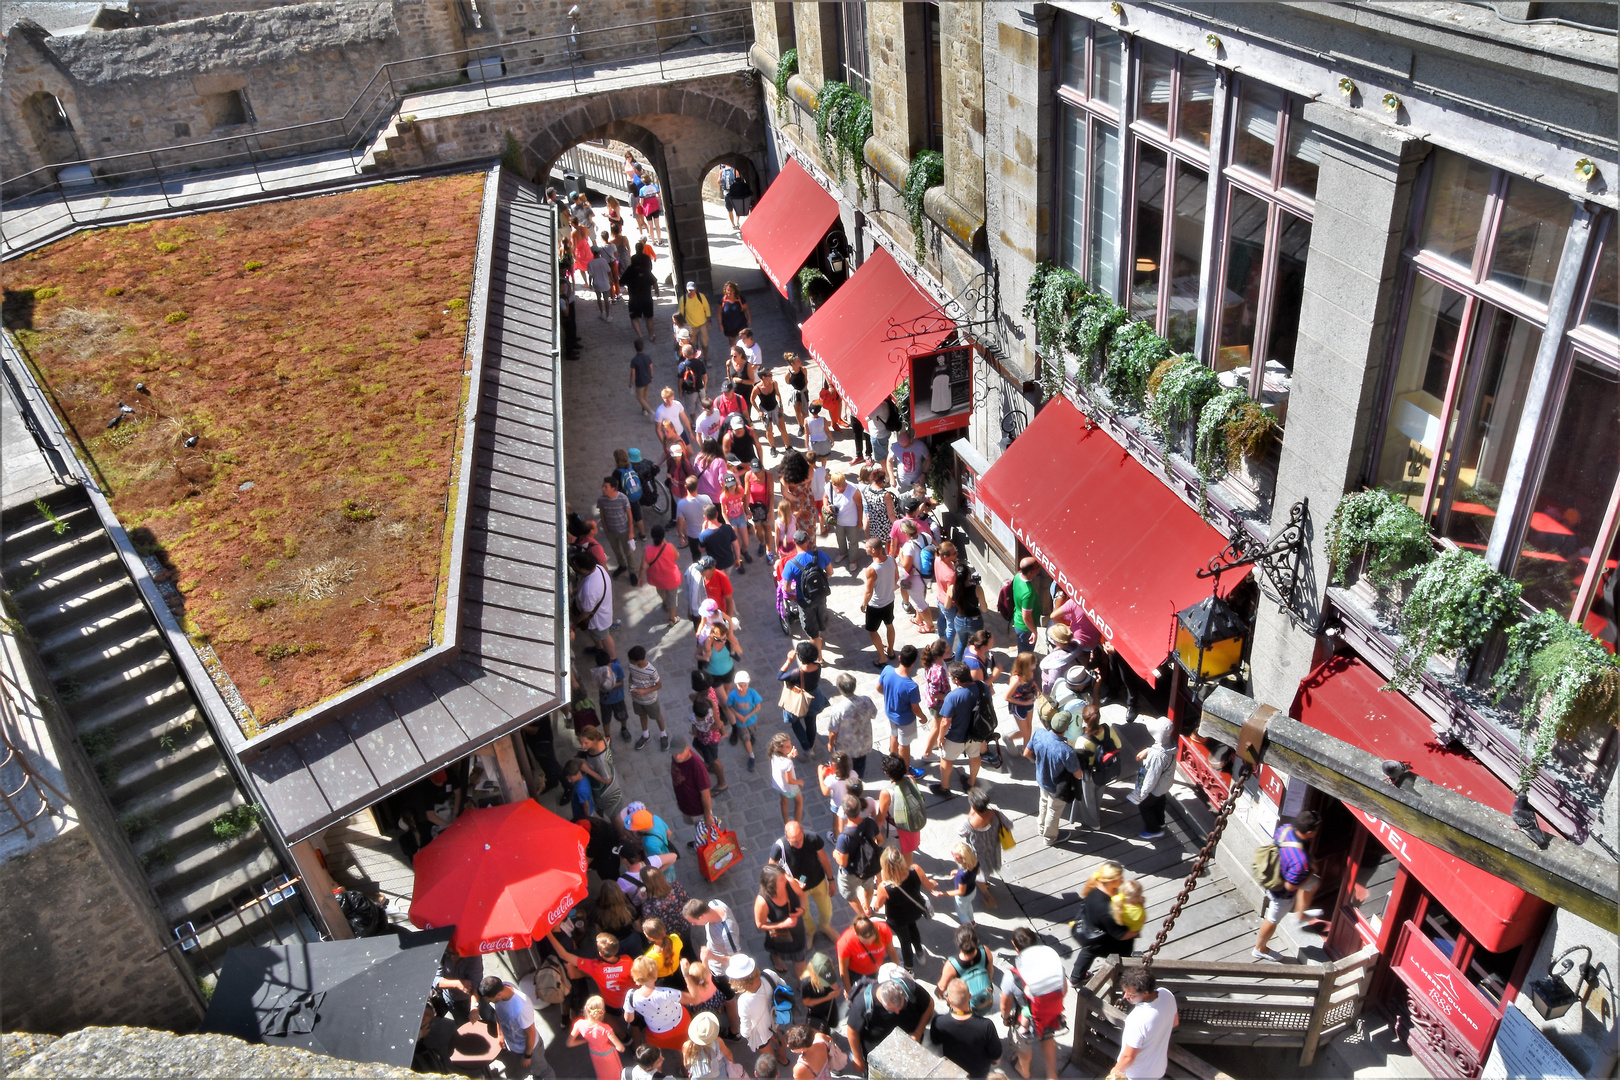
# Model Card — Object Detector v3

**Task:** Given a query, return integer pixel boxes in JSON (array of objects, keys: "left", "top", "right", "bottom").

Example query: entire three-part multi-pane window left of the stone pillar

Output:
[{"left": 1053, "top": 16, "right": 1322, "bottom": 421}]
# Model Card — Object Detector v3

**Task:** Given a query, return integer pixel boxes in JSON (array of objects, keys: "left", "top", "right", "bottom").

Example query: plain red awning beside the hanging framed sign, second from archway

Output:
[{"left": 800, "top": 248, "right": 956, "bottom": 416}]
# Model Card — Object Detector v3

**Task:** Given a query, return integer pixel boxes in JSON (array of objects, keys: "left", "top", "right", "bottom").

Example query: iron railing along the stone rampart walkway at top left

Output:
[{"left": 0, "top": 5, "right": 753, "bottom": 251}]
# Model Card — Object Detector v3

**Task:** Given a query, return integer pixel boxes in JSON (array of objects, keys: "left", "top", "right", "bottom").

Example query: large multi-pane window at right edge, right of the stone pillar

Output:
[{"left": 1372, "top": 151, "right": 1620, "bottom": 634}]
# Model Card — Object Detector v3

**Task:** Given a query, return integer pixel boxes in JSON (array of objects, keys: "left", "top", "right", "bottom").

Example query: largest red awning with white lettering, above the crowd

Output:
[{"left": 978, "top": 397, "right": 1247, "bottom": 680}]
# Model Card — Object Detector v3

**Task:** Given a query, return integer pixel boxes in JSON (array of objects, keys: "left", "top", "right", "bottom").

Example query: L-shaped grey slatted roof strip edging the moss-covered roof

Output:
[{"left": 243, "top": 175, "right": 569, "bottom": 844}]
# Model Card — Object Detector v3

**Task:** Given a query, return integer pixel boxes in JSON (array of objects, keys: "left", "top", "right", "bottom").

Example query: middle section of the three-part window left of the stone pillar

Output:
[{"left": 1128, "top": 42, "right": 1215, "bottom": 351}]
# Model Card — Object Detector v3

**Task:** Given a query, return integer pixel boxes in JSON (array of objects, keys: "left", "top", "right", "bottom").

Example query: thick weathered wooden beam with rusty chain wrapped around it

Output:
[{"left": 1199, "top": 687, "right": 1620, "bottom": 931}]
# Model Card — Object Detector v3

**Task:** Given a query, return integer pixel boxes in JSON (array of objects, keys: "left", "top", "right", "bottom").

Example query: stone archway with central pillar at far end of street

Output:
[{"left": 512, "top": 74, "right": 765, "bottom": 295}]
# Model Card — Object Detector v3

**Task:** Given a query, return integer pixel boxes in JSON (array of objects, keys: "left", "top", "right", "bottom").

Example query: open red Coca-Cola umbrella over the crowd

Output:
[{"left": 410, "top": 798, "right": 588, "bottom": 957}]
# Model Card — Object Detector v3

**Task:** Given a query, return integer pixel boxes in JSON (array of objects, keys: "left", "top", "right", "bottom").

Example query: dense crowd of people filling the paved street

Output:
[{"left": 518, "top": 179, "right": 1175, "bottom": 1080}]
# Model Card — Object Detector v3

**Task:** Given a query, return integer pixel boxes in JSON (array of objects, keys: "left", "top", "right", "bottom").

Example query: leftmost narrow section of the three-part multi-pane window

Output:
[{"left": 1056, "top": 18, "right": 1126, "bottom": 296}]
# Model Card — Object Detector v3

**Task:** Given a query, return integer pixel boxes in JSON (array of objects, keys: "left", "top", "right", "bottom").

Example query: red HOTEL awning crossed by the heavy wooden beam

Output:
[{"left": 1290, "top": 656, "right": 1549, "bottom": 952}]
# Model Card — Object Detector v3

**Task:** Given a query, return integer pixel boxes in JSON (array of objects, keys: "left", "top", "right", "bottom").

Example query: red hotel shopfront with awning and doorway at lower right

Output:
[{"left": 1181, "top": 656, "right": 1552, "bottom": 1077}]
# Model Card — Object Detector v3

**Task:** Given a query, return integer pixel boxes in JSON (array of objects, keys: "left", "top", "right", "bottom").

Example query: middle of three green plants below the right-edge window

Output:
[{"left": 1390, "top": 549, "right": 1521, "bottom": 690}]
